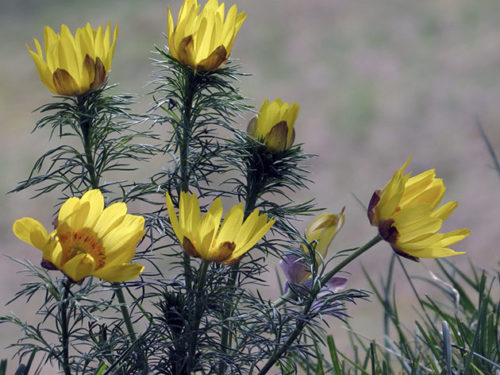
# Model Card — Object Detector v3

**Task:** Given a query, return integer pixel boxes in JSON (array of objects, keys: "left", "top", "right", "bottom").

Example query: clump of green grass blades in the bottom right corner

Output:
[{"left": 294, "top": 256, "right": 500, "bottom": 375}]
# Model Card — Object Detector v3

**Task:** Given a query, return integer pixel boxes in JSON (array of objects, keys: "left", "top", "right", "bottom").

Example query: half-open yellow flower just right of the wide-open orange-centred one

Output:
[{"left": 166, "top": 192, "right": 275, "bottom": 264}]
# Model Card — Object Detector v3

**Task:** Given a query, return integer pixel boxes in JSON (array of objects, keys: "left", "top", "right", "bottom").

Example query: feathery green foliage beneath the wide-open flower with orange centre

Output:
[{"left": 0, "top": 260, "right": 150, "bottom": 374}]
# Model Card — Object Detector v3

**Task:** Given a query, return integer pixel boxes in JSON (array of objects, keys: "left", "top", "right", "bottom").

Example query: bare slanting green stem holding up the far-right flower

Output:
[{"left": 257, "top": 235, "right": 382, "bottom": 375}]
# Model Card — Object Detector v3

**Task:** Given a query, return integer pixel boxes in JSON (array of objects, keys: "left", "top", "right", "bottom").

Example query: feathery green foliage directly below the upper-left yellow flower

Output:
[{"left": 12, "top": 87, "right": 154, "bottom": 197}]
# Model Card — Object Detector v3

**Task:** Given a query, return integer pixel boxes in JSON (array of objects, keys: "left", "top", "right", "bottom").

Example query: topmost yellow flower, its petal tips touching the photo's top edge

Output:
[{"left": 167, "top": 0, "right": 246, "bottom": 71}]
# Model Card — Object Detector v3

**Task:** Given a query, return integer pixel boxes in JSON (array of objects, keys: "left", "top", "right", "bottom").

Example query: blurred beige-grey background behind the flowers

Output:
[{"left": 0, "top": 0, "right": 500, "bottom": 371}]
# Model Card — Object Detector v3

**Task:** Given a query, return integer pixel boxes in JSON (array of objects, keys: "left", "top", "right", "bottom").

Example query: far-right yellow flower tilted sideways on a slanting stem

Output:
[{"left": 368, "top": 159, "right": 470, "bottom": 260}]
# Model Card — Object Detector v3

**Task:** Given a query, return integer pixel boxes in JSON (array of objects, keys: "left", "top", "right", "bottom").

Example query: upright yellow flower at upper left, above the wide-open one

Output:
[{"left": 26, "top": 22, "right": 118, "bottom": 96}]
